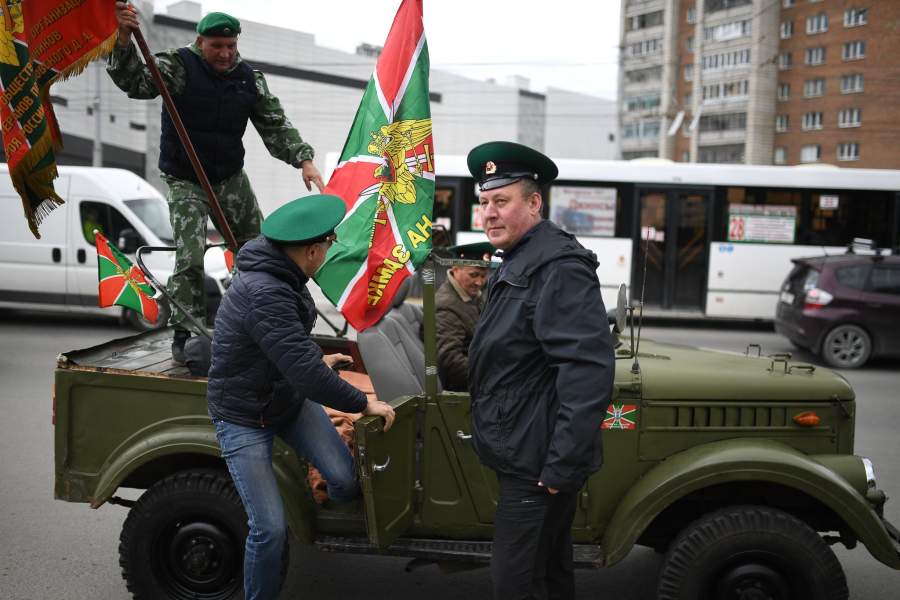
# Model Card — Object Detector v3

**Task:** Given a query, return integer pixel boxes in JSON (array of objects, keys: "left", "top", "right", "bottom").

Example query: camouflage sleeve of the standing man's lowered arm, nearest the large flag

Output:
[{"left": 250, "top": 71, "right": 315, "bottom": 167}]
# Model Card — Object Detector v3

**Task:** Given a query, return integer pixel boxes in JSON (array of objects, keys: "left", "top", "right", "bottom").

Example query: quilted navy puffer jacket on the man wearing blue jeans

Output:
[{"left": 206, "top": 236, "right": 366, "bottom": 427}]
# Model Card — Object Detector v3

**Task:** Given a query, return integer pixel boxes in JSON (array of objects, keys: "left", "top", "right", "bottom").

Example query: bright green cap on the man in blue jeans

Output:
[{"left": 262, "top": 194, "right": 347, "bottom": 246}]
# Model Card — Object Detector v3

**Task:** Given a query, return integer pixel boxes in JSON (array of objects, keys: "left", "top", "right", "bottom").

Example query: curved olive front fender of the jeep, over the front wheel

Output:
[{"left": 602, "top": 438, "right": 900, "bottom": 569}]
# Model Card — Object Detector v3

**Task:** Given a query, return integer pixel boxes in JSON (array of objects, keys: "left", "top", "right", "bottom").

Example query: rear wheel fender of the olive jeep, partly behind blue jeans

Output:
[{"left": 90, "top": 418, "right": 315, "bottom": 543}]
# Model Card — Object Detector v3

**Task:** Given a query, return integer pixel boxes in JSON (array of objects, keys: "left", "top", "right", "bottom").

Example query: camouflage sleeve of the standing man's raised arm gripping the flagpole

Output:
[{"left": 106, "top": 44, "right": 185, "bottom": 100}]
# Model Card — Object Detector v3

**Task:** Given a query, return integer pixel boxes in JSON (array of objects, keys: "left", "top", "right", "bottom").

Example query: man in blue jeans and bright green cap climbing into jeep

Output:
[{"left": 207, "top": 194, "right": 394, "bottom": 600}]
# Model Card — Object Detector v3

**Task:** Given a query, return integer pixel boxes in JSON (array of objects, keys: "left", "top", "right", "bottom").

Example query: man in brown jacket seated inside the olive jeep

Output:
[{"left": 434, "top": 242, "right": 494, "bottom": 392}]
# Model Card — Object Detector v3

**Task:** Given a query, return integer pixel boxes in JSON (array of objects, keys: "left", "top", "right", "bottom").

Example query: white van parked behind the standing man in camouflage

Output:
[{"left": 0, "top": 164, "right": 229, "bottom": 329}]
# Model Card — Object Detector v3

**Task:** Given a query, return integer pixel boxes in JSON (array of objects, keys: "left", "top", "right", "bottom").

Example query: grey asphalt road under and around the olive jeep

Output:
[{"left": 0, "top": 311, "right": 900, "bottom": 600}]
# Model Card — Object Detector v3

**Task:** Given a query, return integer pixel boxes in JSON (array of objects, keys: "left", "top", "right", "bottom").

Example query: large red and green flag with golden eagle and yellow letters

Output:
[{"left": 315, "top": 0, "right": 434, "bottom": 331}]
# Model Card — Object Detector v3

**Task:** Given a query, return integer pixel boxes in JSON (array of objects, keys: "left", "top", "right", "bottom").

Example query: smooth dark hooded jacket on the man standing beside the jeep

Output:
[{"left": 469, "top": 221, "right": 615, "bottom": 491}]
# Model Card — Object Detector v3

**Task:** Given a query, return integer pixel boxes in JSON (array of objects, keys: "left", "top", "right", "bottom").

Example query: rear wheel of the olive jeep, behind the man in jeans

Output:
[{"left": 119, "top": 470, "right": 289, "bottom": 600}]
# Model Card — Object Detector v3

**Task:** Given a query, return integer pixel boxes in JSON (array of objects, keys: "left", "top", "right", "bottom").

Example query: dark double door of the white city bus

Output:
[{"left": 633, "top": 187, "right": 712, "bottom": 311}]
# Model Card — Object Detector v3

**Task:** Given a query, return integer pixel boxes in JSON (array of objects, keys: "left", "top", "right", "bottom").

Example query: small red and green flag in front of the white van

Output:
[{"left": 94, "top": 231, "right": 159, "bottom": 323}]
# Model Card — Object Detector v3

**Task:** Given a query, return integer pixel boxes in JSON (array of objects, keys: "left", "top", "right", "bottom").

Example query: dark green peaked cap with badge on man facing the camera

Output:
[{"left": 466, "top": 142, "right": 559, "bottom": 191}]
